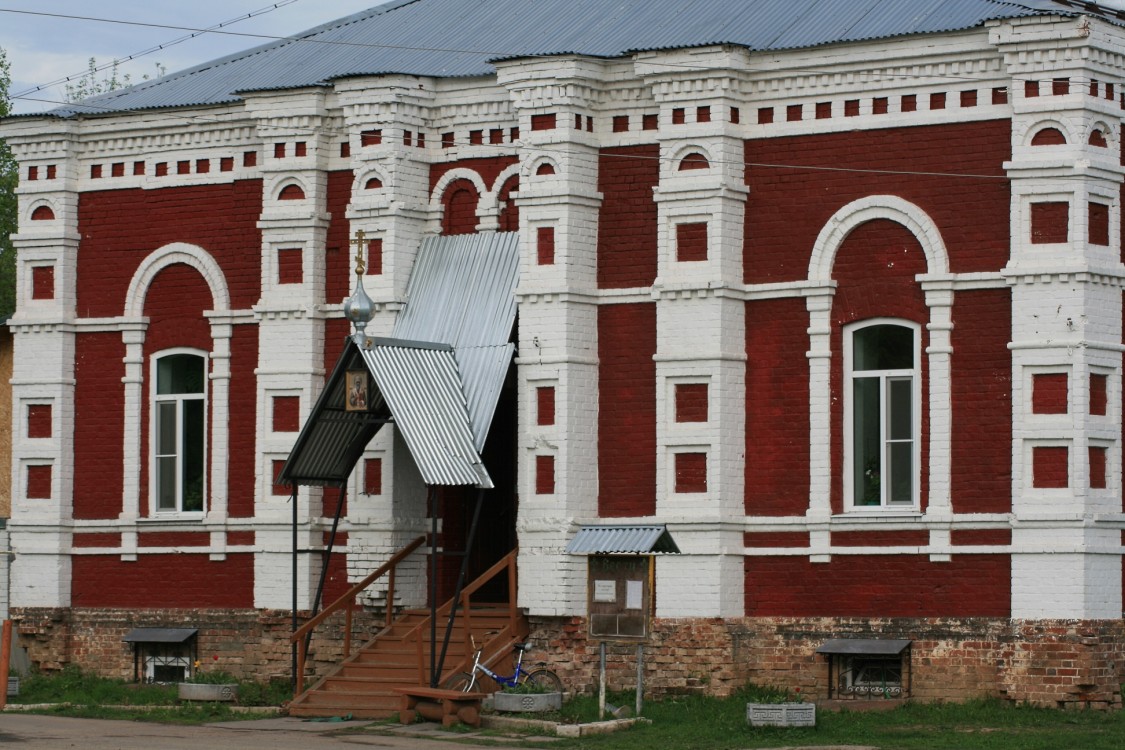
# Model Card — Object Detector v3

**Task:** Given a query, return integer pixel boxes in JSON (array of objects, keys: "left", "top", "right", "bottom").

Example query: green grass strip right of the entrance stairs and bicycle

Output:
[{"left": 481, "top": 688, "right": 1125, "bottom": 750}]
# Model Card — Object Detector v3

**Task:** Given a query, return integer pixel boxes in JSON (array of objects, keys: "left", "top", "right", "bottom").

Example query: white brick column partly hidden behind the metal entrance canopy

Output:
[{"left": 327, "top": 76, "right": 440, "bottom": 606}]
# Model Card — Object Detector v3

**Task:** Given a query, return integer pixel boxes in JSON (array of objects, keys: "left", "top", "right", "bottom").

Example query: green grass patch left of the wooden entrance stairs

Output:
[{"left": 8, "top": 667, "right": 293, "bottom": 724}]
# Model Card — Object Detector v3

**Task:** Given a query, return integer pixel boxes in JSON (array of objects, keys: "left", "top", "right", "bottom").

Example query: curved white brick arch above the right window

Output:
[{"left": 809, "top": 196, "right": 950, "bottom": 283}]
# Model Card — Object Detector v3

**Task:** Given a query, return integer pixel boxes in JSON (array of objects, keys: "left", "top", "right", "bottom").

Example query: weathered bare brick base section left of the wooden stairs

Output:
[{"left": 11, "top": 608, "right": 381, "bottom": 681}]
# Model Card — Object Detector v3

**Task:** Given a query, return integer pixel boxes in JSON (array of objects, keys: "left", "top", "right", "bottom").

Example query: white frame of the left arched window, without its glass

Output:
[{"left": 149, "top": 347, "right": 210, "bottom": 518}]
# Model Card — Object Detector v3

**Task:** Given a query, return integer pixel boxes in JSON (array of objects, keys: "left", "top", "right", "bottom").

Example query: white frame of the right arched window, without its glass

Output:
[{"left": 843, "top": 318, "right": 923, "bottom": 513}]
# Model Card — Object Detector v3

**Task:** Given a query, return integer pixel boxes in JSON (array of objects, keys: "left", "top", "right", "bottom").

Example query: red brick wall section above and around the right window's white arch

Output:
[{"left": 744, "top": 119, "right": 1011, "bottom": 283}]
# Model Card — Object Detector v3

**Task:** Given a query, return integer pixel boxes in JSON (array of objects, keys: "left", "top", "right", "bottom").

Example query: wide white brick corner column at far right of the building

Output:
[{"left": 993, "top": 21, "right": 1125, "bottom": 620}]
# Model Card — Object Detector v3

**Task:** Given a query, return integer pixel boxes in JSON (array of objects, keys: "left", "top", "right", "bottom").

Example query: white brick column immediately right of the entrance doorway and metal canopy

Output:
[{"left": 497, "top": 58, "right": 604, "bottom": 615}]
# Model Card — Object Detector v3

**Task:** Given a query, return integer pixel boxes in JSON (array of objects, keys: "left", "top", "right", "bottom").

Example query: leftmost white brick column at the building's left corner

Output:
[{"left": 5, "top": 120, "right": 81, "bottom": 607}]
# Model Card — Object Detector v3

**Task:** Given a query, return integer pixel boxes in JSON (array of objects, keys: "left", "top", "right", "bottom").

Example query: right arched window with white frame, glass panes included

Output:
[{"left": 844, "top": 320, "right": 921, "bottom": 508}]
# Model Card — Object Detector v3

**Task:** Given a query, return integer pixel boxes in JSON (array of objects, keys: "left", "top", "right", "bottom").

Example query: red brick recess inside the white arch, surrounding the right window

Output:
[{"left": 832, "top": 213, "right": 929, "bottom": 513}]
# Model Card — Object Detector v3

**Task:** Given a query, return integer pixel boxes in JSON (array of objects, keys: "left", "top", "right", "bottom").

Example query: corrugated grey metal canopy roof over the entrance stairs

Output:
[{"left": 277, "top": 233, "right": 520, "bottom": 488}]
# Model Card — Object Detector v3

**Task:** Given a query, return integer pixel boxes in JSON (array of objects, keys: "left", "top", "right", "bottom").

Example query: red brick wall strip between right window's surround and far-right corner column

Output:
[{"left": 950, "top": 289, "right": 1011, "bottom": 513}]
